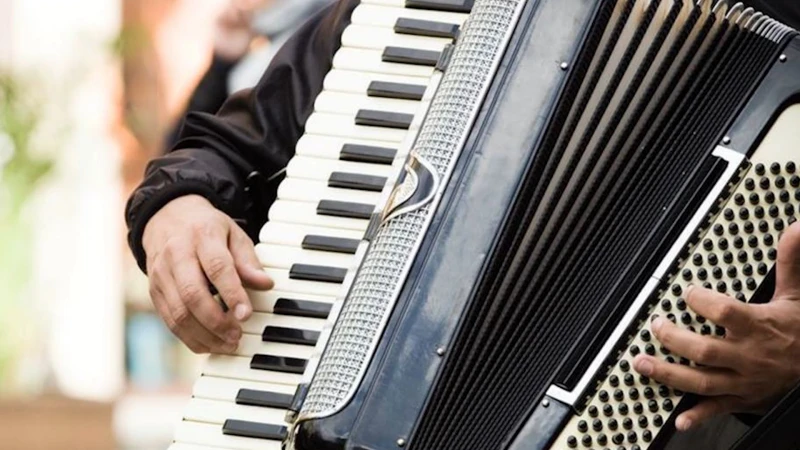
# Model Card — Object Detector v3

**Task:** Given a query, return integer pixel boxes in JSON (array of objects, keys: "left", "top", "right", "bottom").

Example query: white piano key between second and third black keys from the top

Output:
[{"left": 342, "top": 25, "right": 453, "bottom": 52}]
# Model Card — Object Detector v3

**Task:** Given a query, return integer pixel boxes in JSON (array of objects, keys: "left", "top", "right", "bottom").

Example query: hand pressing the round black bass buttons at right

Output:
[{"left": 634, "top": 223, "right": 800, "bottom": 430}]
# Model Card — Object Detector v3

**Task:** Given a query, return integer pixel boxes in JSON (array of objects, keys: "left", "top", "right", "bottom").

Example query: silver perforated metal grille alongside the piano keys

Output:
[{"left": 301, "top": 0, "right": 520, "bottom": 417}]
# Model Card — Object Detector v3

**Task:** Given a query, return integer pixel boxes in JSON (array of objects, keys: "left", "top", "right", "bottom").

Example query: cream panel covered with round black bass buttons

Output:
[{"left": 552, "top": 105, "right": 800, "bottom": 450}]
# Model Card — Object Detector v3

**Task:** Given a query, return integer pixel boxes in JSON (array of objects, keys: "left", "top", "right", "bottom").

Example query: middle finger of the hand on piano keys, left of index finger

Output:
[{"left": 172, "top": 258, "right": 242, "bottom": 341}]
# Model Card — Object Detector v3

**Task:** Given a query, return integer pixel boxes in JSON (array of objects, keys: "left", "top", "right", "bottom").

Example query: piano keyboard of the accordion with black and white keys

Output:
[{"left": 170, "top": 0, "right": 468, "bottom": 450}]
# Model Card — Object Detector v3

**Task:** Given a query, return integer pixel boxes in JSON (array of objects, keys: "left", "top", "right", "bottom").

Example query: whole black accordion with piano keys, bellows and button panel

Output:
[{"left": 173, "top": 0, "right": 800, "bottom": 450}]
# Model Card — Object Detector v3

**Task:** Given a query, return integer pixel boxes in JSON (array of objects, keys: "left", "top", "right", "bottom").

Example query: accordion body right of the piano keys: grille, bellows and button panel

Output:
[{"left": 276, "top": 0, "right": 800, "bottom": 450}]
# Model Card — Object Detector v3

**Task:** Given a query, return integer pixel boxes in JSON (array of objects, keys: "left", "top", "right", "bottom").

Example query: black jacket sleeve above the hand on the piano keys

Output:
[{"left": 125, "top": 0, "right": 358, "bottom": 270}]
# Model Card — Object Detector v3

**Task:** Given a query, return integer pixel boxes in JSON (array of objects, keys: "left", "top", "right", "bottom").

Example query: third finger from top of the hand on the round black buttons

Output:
[{"left": 633, "top": 355, "right": 737, "bottom": 396}]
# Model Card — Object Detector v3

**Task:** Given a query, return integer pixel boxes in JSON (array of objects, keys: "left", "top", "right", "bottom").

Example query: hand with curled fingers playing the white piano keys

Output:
[{"left": 142, "top": 195, "right": 273, "bottom": 353}]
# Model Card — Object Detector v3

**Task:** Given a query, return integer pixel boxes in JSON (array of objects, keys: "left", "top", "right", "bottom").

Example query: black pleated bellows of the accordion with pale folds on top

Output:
[{"left": 412, "top": 0, "right": 774, "bottom": 450}]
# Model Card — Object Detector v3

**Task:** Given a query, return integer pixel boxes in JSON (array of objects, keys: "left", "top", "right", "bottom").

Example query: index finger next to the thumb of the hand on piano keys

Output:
[{"left": 197, "top": 232, "right": 253, "bottom": 321}]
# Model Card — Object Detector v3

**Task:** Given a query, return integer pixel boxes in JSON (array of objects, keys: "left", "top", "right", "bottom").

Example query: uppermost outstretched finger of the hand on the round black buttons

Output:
[{"left": 686, "top": 286, "right": 753, "bottom": 334}]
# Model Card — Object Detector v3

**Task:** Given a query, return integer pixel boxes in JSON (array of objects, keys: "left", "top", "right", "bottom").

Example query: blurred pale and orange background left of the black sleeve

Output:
[{"left": 0, "top": 0, "right": 330, "bottom": 450}]
